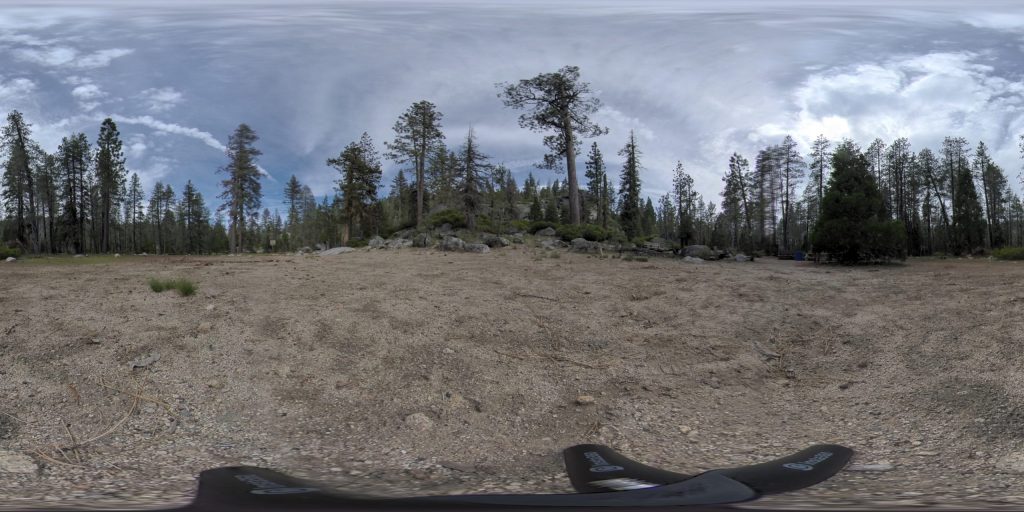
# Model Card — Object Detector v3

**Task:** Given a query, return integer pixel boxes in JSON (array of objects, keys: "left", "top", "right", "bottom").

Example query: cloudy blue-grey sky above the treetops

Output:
[{"left": 0, "top": 0, "right": 1024, "bottom": 214}]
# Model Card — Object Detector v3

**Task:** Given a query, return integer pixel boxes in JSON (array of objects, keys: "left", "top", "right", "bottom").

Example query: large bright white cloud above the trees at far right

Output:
[{"left": 750, "top": 51, "right": 1024, "bottom": 177}]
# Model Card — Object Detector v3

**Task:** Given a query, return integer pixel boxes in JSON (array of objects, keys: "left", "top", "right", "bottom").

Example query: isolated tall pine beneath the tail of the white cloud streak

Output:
[{"left": 218, "top": 123, "right": 263, "bottom": 253}]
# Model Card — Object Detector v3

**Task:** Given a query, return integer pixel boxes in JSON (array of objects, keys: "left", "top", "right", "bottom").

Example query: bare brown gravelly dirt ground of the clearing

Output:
[{"left": 0, "top": 246, "right": 1024, "bottom": 510}]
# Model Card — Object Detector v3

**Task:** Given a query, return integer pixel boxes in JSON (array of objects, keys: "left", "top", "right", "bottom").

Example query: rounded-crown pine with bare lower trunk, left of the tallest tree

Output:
[{"left": 384, "top": 101, "right": 444, "bottom": 228}]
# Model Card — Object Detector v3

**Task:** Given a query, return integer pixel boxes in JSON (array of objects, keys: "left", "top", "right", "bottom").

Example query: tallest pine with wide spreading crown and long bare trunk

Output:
[{"left": 499, "top": 66, "right": 608, "bottom": 224}]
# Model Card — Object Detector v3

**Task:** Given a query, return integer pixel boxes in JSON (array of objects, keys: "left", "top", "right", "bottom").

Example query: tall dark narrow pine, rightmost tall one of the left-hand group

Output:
[{"left": 96, "top": 118, "right": 126, "bottom": 252}]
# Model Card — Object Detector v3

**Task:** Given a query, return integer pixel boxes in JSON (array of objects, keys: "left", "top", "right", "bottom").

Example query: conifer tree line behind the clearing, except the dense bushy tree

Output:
[{"left": 0, "top": 67, "right": 1024, "bottom": 255}]
